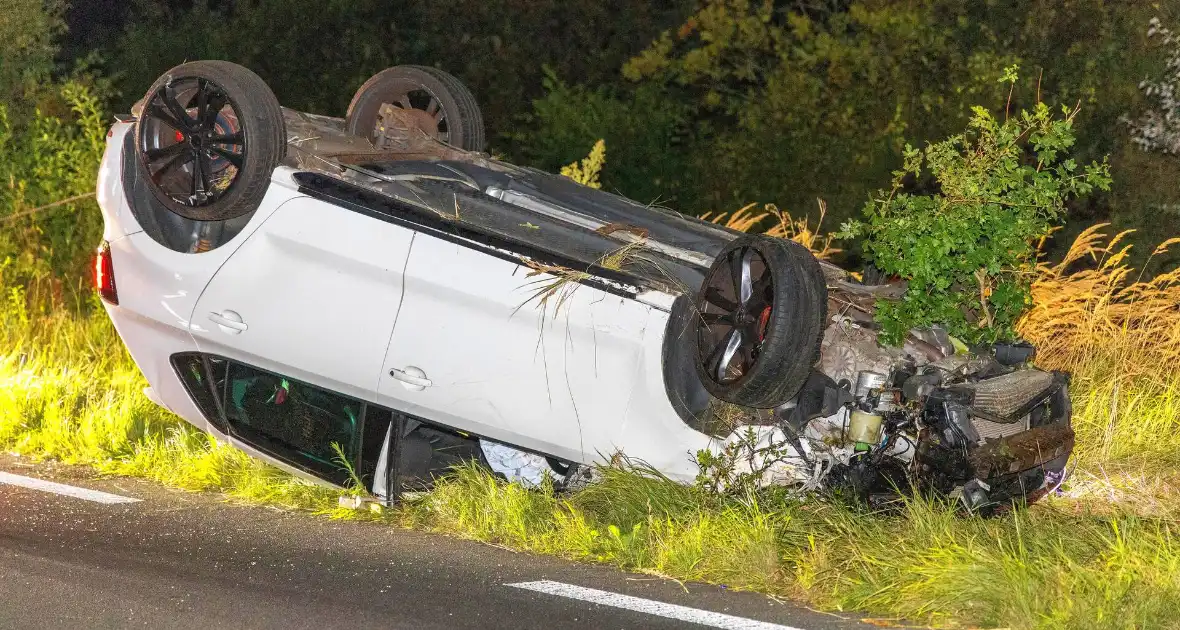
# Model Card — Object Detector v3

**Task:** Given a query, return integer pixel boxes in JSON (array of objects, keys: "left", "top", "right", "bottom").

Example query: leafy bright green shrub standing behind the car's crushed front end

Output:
[{"left": 843, "top": 97, "right": 1110, "bottom": 343}]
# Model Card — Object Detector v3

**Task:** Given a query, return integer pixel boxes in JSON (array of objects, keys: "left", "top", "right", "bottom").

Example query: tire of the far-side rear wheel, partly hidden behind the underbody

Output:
[{"left": 345, "top": 66, "right": 486, "bottom": 151}]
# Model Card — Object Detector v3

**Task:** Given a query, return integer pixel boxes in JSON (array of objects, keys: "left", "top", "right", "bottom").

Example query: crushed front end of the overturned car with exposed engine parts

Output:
[{"left": 730, "top": 284, "right": 1074, "bottom": 513}]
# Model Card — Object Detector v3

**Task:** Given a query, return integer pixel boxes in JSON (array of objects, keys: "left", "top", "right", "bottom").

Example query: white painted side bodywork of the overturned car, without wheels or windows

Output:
[{"left": 99, "top": 122, "right": 769, "bottom": 481}]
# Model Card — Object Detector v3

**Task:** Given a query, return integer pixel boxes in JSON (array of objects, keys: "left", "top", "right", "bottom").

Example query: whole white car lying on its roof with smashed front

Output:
[{"left": 96, "top": 61, "right": 1073, "bottom": 508}]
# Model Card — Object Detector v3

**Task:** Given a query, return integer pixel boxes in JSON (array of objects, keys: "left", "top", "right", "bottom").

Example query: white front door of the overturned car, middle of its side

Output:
[{"left": 379, "top": 234, "right": 634, "bottom": 461}]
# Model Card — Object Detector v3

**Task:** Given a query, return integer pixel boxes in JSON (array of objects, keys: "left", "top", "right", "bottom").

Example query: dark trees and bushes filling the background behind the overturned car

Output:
[{"left": 0, "top": 0, "right": 1180, "bottom": 267}]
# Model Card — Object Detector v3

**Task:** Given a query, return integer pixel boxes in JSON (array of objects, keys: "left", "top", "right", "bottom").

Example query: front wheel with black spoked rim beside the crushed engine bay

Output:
[{"left": 690, "top": 236, "right": 827, "bottom": 409}]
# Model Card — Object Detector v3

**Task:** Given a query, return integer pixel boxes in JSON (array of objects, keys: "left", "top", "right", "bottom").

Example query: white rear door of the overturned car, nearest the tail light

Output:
[{"left": 191, "top": 197, "right": 414, "bottom": 399}]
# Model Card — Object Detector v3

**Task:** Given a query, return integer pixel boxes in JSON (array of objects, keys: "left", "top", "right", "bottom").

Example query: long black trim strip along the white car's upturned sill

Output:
[{"left": 293, "top": 171, "right": 643, "bottom": 300}]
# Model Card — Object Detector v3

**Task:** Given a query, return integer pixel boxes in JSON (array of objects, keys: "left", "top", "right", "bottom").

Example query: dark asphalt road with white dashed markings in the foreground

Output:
[{"left": 0, "top": 458, "right": 887, "bottom": 630}]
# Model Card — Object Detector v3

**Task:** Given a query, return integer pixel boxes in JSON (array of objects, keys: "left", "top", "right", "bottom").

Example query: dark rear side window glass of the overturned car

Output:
[{"left": 222, "top": 362, "right": 365, "bottom": 485}]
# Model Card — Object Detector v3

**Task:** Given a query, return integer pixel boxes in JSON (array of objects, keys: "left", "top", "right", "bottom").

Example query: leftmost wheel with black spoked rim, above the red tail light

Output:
[{"left": 135, "top": 61, "right": 287, "bottom": 221}]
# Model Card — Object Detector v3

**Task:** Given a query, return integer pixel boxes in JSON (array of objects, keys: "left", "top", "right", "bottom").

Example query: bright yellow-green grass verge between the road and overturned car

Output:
[{"left": 0, "top": 302, "right": 1180, "bottom": 628}]
